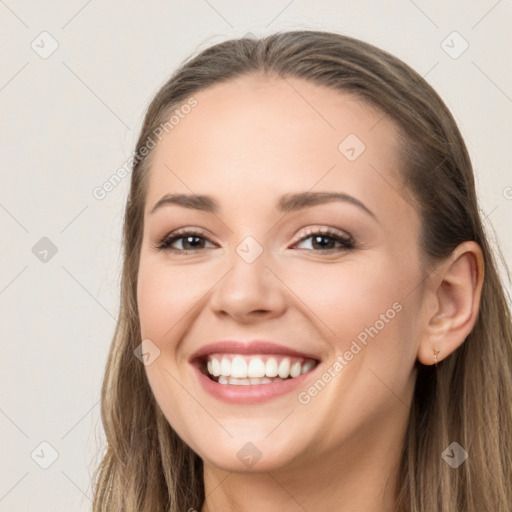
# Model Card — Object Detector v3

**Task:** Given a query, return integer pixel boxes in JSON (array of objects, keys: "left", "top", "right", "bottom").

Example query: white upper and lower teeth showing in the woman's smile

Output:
[{"left": 201, "top": 353, "right": 319, "bottom": 386}]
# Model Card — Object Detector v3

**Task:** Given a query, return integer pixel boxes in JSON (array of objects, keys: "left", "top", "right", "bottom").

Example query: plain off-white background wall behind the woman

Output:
[{"left": 0, "top": 0, "right": 512, "bottom": 512}]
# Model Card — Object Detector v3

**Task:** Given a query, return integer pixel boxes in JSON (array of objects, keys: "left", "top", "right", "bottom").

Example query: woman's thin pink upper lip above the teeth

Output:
[{"left": 190, "top": 340, "right": 318, "bottom": 361}]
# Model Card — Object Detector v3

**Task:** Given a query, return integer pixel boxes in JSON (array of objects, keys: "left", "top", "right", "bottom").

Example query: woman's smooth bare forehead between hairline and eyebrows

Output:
[{"left": 143, "top": 74, "right": 412, "bottom": 221}]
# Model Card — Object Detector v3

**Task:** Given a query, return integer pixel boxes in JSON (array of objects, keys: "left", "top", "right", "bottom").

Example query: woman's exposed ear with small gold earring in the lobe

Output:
[{"left": 418, "top": 241, "right": 484, "bottom": 365}]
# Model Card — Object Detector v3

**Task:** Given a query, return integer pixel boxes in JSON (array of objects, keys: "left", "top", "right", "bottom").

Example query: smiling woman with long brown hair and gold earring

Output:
[{"left": 94, "top": 31, "right": 512, "bottom": 512}]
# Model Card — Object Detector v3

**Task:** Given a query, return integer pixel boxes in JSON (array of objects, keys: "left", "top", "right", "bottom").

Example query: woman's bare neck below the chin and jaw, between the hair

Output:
[{"left": 201, "top": 408, "right": 407, "bottom": 512}]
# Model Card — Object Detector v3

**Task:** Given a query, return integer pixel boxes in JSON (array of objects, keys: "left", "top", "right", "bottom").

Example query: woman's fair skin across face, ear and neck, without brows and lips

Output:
[{"left": 137, "top": 75, "right": 483, "bottom": 512}]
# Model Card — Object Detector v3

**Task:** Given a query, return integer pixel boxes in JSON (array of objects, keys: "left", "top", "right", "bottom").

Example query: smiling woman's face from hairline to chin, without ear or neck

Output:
[{"left": 137, "top": 75, "right": 423, "bottom": 471}]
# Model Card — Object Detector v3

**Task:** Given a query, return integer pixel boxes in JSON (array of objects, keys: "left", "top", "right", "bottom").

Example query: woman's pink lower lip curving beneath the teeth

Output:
[{"left": 192, "top": 365, "right": 318, "bottom": 405}]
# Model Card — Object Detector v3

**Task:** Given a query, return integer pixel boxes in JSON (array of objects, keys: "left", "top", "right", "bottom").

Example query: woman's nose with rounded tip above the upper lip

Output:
[{"left": 210, "top": 242, "right": 286, "bottom": 323}]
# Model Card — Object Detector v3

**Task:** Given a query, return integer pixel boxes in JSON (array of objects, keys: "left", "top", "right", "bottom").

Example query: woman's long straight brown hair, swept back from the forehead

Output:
[{"left": 93, "top": 30, "right": 512, "bottom": 512}]
